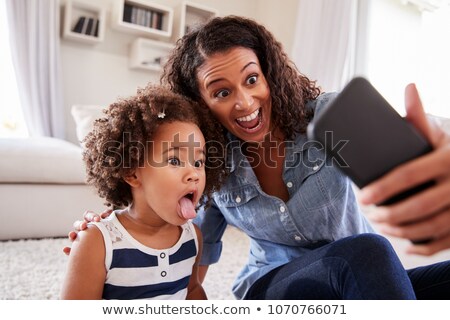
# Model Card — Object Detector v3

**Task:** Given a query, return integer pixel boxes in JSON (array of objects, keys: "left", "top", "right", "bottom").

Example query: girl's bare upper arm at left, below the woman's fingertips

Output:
[{"left": 61, "top": 226, "right": 106, "bottom": 300}]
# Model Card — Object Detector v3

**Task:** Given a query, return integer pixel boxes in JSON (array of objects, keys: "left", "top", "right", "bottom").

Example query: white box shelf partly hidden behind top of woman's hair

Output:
[{"left": 174, "top": 1, "right": 219, "bottom": 40}]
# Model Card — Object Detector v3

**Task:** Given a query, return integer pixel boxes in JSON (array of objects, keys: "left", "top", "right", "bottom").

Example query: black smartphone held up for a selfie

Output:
[{"left": 307, "top": 77, "right": 434, "bottom": 243}]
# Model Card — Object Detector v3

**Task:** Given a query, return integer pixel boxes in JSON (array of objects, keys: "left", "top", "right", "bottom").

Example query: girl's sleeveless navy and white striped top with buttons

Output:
[{"left": 94, "top": 212, "right": 198, "bottom": 300}]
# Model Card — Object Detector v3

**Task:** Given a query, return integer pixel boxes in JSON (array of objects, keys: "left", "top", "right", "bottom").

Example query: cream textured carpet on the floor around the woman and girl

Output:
[{"left": 0, "top": 222, "right": 450, "bottom": 300}]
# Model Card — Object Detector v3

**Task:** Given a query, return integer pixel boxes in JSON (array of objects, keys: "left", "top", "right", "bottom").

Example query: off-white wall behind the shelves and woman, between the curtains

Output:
[{"left": 61, "top": 0, "right": 298, "bottom": 142}]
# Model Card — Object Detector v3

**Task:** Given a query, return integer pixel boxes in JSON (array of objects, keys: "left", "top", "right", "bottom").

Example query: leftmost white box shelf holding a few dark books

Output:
[{"left": 63, "top": 0, "right": 106, "bottom": 44}]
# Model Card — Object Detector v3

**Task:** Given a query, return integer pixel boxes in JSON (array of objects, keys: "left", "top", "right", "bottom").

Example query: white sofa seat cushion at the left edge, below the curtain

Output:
[{"left": 0, "top": 137, "right": 86, "bottom": 184}]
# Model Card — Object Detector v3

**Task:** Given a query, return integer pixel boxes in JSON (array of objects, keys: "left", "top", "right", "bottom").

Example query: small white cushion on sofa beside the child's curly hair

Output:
[{"left": 71, "top": 104, "right": 105, "bottom": 145}]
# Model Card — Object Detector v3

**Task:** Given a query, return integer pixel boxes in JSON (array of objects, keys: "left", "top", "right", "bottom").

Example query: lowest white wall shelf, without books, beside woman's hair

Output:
[{"left": 129, "top": 38, "right": 174, "bottom": 72}]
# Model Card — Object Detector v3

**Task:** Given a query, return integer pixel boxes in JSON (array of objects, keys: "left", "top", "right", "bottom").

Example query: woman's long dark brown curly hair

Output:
[{"left": 161, "top": 16, "right": 320, "bottom": 139}]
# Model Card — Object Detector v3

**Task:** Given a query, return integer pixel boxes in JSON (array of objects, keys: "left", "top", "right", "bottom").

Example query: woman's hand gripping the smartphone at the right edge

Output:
[{"left": 360, "top": 85, "right": 450, "bottom": 255}]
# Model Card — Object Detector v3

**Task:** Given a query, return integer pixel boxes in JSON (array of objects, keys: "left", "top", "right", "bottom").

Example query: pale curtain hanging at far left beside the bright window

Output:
[{"left": 3, "top": 0, "right": 65, "bottom": 138}]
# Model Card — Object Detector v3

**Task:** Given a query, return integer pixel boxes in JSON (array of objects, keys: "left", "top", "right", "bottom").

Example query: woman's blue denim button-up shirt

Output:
[{"left": 194, "top": 94, "right": 373, "bottom": 299}]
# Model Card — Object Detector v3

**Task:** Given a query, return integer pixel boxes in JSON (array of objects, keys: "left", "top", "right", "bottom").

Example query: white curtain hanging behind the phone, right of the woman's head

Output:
[{"left": 292, "top": 0, "right": 370, "bottom": 91}]
